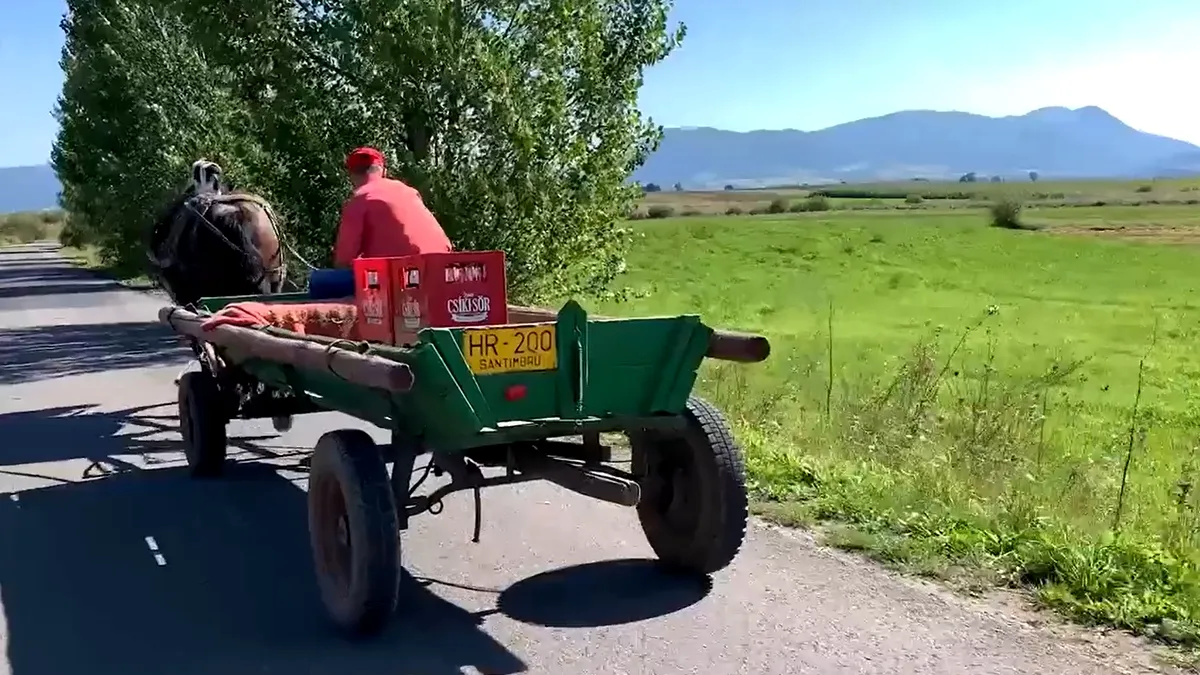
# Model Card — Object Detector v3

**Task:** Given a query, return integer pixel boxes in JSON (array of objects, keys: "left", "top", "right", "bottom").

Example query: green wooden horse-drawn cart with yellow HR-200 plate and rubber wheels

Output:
[{"left": 160, "top": 294, "right": 769, "bottom": 633}]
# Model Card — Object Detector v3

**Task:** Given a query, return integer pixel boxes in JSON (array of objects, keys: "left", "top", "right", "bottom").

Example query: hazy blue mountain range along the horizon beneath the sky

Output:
[{"left": 0, "top": 107, "right": 1200, "bottom": 214}]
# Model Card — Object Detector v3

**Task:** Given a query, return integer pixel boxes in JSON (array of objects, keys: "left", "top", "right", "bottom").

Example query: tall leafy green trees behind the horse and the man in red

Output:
[{"left": 53, "top": 0, "right": 683, "bottom": 299}]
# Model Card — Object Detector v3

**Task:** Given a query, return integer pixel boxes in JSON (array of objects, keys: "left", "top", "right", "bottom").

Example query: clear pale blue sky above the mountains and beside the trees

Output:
[{"left": 0, "top": 0, "right": 1200, "bottom": 166}]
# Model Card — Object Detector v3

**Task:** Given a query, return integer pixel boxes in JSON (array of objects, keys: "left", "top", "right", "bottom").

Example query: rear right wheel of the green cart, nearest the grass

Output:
[{"left": 630, "top": 396, "right": 749, "bottom": 574}]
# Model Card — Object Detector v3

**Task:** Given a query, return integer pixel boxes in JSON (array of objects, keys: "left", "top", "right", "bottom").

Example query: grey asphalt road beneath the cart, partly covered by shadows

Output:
[{"left": 0, "top": 245, "right": 1180, "bottom": 675}]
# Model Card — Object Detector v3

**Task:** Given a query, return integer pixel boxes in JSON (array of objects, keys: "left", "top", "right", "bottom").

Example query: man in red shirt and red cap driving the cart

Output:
[{"left": 334, "top": 148, "right": 452, "bottom": 268}]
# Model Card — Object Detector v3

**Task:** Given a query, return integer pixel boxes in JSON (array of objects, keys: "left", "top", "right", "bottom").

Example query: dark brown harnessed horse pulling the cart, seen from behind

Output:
[{"left": 146, "top": 159, "right": 290, "bottom": 431}]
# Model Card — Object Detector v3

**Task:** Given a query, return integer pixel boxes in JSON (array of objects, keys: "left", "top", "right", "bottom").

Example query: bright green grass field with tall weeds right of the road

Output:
[{"left": 598, "top": 198, "right": 1200, "bottom": 644}]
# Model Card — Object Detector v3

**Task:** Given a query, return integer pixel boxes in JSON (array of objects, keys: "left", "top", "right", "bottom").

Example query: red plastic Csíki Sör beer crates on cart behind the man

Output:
[{"left": 354, "top": 251, "right": 509, "bottom": 345}]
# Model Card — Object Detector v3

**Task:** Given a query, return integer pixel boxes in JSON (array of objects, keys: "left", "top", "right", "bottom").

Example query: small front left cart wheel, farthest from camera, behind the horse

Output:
[{"left": 179, "top": 371, "right": 229, "bottom": 478}]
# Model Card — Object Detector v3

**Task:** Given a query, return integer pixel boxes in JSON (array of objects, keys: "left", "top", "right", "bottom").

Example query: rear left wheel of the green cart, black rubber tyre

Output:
[{"left": 308, "top": 429, "right": 400, "bottom": 634}]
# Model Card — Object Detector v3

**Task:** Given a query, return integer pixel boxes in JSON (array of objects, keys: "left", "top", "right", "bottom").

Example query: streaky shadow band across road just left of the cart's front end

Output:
[{"left": 0, "top": 319, "right": 191, "bottom": 384}]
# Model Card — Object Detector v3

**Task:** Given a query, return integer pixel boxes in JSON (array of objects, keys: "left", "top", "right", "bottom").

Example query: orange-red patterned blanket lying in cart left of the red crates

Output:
[{"left": 202, "top": 303, "right": 359, "bottom": 340}]
